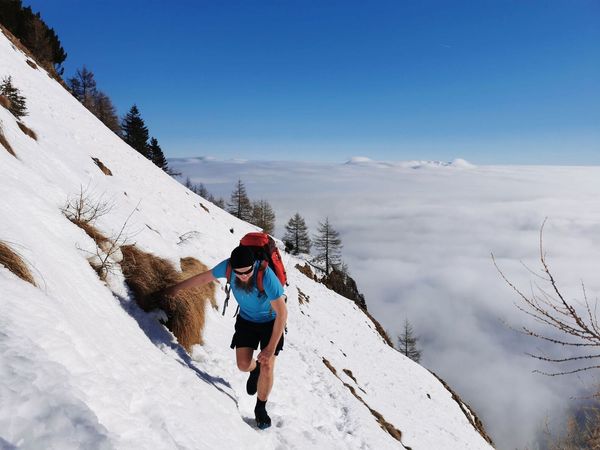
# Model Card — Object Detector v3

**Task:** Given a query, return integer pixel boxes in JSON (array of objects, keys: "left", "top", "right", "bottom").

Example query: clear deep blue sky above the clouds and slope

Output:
[{"left": 24, "top": 0, "right": 600, "bottom": 164}]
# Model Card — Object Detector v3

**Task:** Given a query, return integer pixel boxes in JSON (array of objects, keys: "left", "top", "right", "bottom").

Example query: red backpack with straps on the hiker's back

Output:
[{"left": 223, "top": 232, "right": 287, "bottom": 315}]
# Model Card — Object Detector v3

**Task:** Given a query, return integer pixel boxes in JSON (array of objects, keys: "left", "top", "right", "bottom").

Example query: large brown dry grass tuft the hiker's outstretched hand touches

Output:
[{"left": 121, "top": 245, "right": 214, "bottom": 353}]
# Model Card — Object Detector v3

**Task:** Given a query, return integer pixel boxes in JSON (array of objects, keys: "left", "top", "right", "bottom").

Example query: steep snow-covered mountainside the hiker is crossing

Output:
[{"left": 0, "top": 29, "right": 490, "bottom": 450}]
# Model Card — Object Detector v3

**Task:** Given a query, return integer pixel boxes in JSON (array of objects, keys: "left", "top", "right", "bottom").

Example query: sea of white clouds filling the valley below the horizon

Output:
[{"left": 169, "top": 157, "right": 600, "bottom": 449}]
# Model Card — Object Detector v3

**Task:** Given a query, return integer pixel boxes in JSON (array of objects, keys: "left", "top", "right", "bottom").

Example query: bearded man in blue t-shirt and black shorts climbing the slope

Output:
[{"left": 165, "top": 245, "right": 287, "bottom": 429}]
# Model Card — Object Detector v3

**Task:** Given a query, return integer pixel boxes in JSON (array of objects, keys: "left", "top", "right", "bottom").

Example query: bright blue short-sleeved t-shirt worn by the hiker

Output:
[{"left": 211, "top": 259, "right": 283, "bottom": 323}]
